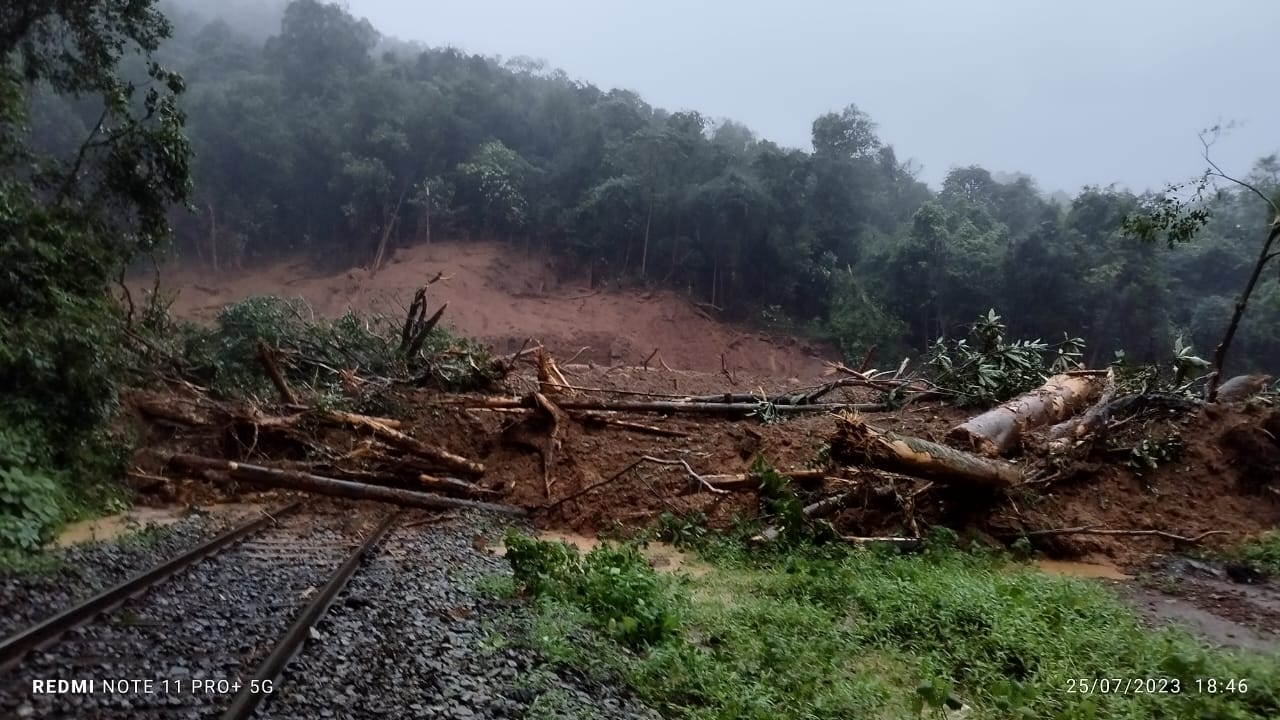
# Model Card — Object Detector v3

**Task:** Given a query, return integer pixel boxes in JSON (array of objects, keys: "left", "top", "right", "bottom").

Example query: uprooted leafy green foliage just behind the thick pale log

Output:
[{"left": 925, "top": 310, "right": 1084, "bottom": 407}]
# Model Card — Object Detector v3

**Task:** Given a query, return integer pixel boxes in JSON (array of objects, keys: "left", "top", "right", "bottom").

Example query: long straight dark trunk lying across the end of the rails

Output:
[{"left": 169, "top": 455, "right": 527, "bottom": 518}]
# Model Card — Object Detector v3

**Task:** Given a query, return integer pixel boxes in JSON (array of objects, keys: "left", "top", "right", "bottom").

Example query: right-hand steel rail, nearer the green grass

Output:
[{"left": 221, "top": 512, "right": 399, "bottom": 720}]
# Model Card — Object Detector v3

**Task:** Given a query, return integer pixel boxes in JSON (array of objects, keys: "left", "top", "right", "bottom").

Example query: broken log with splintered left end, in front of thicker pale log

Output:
[{"left": 831, "top": 414, "right": 1021, "bottom": 489}]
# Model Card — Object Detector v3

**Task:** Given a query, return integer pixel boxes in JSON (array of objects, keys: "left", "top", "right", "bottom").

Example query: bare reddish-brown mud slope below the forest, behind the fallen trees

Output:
[{"left": 147, "top": 242, "right": 833, "bottom": 378}]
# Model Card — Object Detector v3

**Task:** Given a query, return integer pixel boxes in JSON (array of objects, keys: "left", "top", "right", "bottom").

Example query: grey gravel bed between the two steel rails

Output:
[{"left": 0, "top": 499, "right": 378, "bottom": 719}]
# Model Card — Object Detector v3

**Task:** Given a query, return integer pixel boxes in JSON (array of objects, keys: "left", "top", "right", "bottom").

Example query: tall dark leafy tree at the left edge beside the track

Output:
[{"left": 0, "top": 0, "right": 189, "bottom": 546}]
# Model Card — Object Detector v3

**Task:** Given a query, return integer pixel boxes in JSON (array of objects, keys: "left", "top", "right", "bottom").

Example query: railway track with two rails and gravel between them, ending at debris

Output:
[{"left": 0, "top": 503, "right": 398, "bottom": 720}]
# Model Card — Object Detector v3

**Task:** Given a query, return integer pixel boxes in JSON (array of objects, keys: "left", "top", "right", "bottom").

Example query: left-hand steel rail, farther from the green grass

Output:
[{"left": 0, "top": 502, "right": 302, "bottom": 670}]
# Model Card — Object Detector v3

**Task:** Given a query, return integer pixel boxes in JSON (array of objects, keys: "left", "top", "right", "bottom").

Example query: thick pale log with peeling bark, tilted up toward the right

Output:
[{"left": 947, "top": 374, "right": 1102, "bottom": 457}]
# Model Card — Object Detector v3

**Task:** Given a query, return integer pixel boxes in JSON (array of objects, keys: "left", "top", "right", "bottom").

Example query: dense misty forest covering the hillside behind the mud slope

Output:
[{"left": 20, "top": 0, "right": 1280, "bottom": 370}]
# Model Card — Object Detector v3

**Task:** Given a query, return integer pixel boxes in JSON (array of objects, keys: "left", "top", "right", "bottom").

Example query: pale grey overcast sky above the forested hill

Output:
[{"left": 348, "top": 0, "right": 1280, "bottom": 192}]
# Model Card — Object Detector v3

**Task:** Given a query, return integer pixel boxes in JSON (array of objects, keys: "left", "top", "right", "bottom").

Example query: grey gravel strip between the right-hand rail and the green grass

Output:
[{"left": 259, "top": 514, "right": 658, "bottom": 720}]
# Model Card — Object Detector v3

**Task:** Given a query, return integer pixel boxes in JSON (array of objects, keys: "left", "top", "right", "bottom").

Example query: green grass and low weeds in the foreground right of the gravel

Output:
[{"left": 496, "top": 527, "right": 1280, "bottom": 720}]
